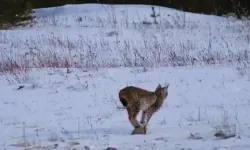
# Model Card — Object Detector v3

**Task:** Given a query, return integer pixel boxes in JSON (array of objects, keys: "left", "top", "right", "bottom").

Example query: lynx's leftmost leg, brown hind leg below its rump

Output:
[{"left": 127, "top": 107, "right": 141, "bottom": 128}]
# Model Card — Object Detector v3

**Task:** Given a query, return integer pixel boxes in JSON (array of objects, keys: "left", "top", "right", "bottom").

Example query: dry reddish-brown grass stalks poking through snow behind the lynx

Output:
[{"left": 0, "top": 5, "right": 250, "bottom": 76}]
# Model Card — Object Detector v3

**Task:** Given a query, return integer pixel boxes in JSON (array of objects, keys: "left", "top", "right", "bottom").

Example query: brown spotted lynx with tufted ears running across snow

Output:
[{"left": 119, "top": 84, "right": 169, "bottom": 132}]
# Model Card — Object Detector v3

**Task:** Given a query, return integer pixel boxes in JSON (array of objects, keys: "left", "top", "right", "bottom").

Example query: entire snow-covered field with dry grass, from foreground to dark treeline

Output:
[{"left": 0, "top": 4, "right": 250, "bottom": 150}]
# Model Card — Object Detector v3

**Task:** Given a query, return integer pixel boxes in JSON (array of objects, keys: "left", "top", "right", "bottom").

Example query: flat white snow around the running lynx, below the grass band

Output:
[{"left": 0, "top": 67, "right": 250, "bottom": 150}]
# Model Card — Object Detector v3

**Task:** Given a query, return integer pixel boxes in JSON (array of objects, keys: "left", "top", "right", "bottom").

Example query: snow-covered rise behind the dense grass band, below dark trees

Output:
[{"left": 0, "top": 4, "right": 250, "bottom": 68}]
